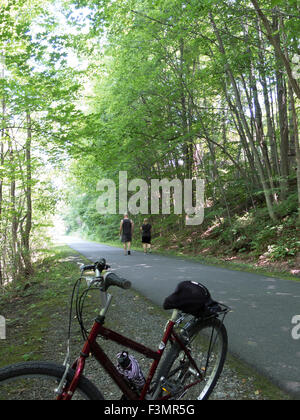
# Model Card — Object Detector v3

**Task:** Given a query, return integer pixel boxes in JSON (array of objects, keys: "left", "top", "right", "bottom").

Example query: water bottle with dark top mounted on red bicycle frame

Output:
[{"left": 117, "top": 351, "right": 146, "bottom": 392}]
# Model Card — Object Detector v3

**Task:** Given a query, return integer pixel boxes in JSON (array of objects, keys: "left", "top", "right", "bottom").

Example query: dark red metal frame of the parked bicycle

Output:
[{"left": 58, "top": 311, "right": 203, "bottom": 400}]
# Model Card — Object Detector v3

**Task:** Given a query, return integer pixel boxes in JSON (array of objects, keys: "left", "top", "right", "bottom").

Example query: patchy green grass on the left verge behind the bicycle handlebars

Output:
[{"left": 0, "top": 247, "right": 83, "bottom": 367}]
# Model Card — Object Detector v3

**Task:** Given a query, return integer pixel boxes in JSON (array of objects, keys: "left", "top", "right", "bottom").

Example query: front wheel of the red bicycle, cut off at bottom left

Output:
[{"left": 0, "top": 362, "right": 104, "bottom": 400}]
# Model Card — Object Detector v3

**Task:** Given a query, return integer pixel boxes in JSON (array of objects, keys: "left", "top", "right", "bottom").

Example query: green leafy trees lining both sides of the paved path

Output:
[{"left": 0, "top": 0, "right": 300, "bottom": 283}]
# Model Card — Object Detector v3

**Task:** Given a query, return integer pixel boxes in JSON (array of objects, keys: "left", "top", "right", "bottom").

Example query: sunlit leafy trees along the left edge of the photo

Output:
[{"left": 0, "top": 0, "right": 84, "bottom": 285}]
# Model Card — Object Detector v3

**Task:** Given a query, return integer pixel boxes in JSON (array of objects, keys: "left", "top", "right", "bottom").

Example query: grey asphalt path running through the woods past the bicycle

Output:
[{"left": 63, "top": 237, "right": 300, "bottom": 399}]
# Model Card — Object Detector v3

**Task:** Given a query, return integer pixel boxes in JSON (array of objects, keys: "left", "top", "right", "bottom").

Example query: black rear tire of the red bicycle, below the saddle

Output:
[{"left": 156, "top": 318, "right": 228, "bottom": 400}]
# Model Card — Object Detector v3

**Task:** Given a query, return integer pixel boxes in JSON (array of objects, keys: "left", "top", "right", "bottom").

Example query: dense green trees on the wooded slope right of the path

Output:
[{"left": 63, "top": 0, "right": 300, "bottom": 258}]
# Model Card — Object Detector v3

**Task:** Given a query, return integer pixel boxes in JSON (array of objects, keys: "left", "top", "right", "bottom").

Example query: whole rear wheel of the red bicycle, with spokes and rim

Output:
[{"left": 158, "top": 318, "right": 228, "bottom": 400}]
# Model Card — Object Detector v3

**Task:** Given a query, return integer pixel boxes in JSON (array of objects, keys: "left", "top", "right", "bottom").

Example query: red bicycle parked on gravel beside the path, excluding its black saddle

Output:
[{"left": 0, "top": 259, "right": 229, "bottom": 400}]
